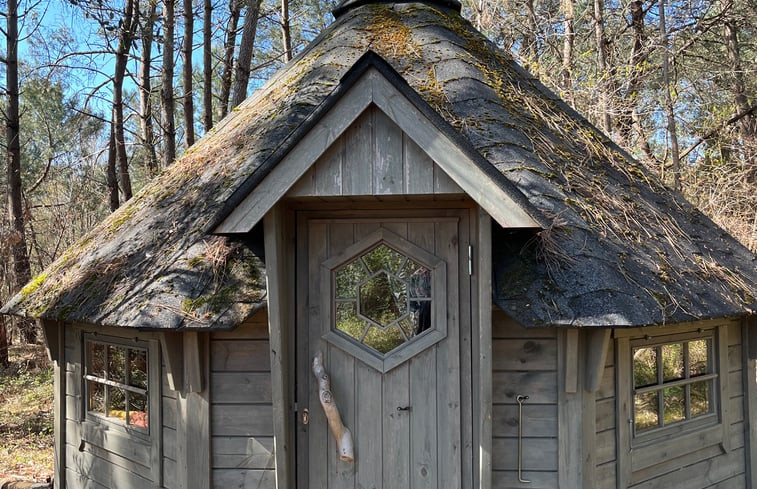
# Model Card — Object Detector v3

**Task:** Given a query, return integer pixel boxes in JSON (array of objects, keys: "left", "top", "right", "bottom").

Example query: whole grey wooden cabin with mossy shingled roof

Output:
[{"left": 3, "top": 0, "right": 757, "bottom": 489}]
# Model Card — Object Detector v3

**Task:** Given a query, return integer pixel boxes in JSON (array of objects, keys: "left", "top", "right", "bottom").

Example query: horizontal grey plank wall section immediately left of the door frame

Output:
[{"left": 210, "top": 312, "right": 275, "bottom": 489}]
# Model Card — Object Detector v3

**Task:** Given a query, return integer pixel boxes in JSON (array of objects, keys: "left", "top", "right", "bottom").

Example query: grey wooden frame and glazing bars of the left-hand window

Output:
[{"left": 81, "top": 333, "right": 160, "bottom": 441}]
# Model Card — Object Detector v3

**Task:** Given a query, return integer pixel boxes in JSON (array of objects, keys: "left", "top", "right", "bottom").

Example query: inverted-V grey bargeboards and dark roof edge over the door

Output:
[{"left": 213, "top": 51, "right": 547, "bottom": 235}]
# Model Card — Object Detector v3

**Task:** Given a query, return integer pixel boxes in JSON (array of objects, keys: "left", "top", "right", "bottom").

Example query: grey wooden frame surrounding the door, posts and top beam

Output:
[{"left": 264, "top": 196, "right": 492, "bottom": 489}]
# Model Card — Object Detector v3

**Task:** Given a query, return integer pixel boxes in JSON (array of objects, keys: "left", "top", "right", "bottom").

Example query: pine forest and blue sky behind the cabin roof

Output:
[{"left": 0, "top": 0, "right": 757, "bottom": 476}]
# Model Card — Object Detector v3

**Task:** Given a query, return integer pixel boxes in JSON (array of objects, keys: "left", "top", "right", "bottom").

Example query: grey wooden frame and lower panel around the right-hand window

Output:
[{"left": 614, "top": 321, "right": 730, "bottom": 488}]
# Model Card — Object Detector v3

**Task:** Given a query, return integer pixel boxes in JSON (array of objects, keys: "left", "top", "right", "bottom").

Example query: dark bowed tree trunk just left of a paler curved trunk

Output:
[{"left": 113, "top": 0, "right": 138, "bottom": 201}]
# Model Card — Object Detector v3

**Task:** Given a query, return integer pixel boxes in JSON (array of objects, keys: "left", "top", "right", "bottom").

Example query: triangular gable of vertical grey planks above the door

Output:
[{"left": 287, "top": 106, "right": 463, "bottom": 197}]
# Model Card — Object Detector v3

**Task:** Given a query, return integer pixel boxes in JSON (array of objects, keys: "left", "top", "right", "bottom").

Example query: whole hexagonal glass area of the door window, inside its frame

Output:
[{"left": 333, "top": 243, "right": 433, "bottom": 354}]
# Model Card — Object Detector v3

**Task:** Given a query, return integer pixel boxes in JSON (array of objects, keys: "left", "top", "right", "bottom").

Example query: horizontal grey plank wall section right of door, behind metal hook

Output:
[{"left": 492, "top": 310, "right": 558, "bottom": 489}]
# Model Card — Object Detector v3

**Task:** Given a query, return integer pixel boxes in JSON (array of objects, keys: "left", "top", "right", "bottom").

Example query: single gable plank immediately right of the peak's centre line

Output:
[{"left": 373, "top": 110, "right": 404, "bottom": 195}]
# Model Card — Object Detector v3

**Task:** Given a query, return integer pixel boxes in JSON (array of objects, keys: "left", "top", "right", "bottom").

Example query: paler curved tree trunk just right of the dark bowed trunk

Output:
[{"left": 139, "top": 0, "right": 158, "bottom": 177}]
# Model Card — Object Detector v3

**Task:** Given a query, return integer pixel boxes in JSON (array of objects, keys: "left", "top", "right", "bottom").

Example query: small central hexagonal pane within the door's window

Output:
[{"left": 358, "top": 271, "right": 408, "bottom": 327}]
